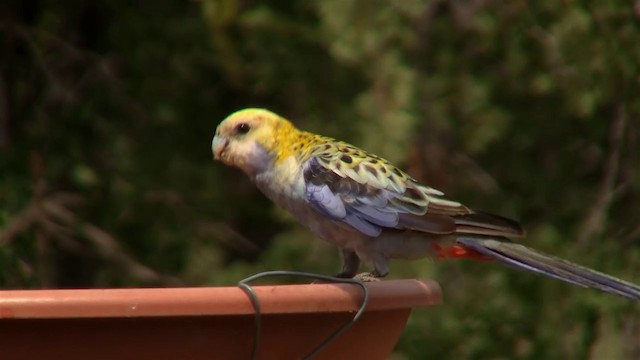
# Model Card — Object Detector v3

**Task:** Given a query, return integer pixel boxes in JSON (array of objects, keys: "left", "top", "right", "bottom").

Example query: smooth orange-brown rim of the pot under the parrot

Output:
[{"left": 0, "top": 279, "right": 442, "bottom": 319}]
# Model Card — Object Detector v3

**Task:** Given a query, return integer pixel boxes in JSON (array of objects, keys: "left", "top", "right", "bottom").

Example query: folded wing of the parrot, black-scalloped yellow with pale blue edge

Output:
[{"left": 303, "top": 142, "right": 522, "bottom": 237}]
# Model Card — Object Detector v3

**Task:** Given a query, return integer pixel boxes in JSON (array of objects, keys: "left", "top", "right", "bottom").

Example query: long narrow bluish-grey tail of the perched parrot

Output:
[{"left": 457, "top": 236, "right": 640, "bottom": 300}]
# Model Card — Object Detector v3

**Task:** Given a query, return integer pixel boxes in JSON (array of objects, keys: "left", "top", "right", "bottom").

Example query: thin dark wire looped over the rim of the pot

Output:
[{"left": 238, "top": 271, "right": 369, "bottom": 360}]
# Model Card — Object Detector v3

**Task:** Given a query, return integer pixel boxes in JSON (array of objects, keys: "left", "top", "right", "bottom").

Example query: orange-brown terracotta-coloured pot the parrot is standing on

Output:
[{"left": 0, "top": 280, "right": 441, "bottom": 360}]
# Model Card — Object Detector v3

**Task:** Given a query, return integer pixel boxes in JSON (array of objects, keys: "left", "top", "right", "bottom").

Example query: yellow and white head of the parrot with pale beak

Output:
[{"left": 211, "top": 109, "right": 299, "bottom": 176}]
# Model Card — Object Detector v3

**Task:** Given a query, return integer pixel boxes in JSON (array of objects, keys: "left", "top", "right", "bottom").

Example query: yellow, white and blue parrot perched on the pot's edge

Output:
[{"left": 211, "top": 108, "right": 640, "bottom": 300}]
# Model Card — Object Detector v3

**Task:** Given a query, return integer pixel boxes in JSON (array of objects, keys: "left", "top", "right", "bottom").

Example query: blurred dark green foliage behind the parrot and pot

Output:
[{"left": 0, "top": 0, "right": 640, "bottom": 359}]
